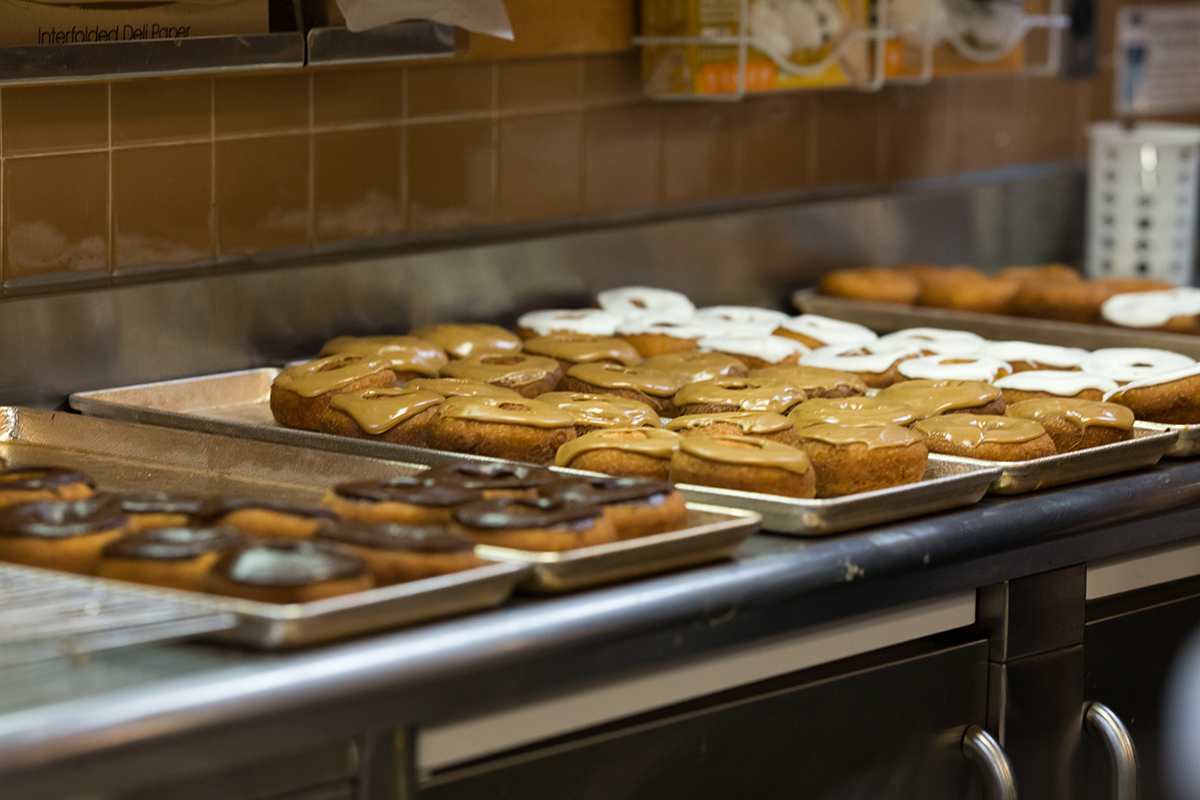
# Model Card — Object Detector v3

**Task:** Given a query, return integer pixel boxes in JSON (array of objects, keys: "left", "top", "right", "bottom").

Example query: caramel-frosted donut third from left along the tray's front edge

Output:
[{"left": 426, "top": 397, "right": 575, "bottom": 464}]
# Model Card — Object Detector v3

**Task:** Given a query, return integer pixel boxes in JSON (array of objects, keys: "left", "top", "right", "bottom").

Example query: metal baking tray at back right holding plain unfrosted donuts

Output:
[{"left": 792, "top": 289, "right": 1200, "bottom": 360}]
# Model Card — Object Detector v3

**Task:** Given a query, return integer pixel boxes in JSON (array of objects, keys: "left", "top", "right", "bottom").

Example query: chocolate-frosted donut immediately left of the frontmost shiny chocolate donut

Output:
[{"left": 96, "top": 528, "right": 247, "bottom": 591}]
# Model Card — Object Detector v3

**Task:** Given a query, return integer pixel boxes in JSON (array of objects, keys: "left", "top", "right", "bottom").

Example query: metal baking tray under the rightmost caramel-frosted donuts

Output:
[{"left": 931, "top": 423, "right": 1178, "bottom": 494}]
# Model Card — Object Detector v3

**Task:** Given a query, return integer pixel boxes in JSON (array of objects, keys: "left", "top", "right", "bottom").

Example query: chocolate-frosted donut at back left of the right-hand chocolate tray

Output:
[{"left": 323, "top": 474, "right": 484, "bottom": 525}]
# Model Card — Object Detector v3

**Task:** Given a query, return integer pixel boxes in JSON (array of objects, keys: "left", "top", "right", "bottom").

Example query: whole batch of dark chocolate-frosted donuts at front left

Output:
[{"left": 0, "top": 462, "right": 686, "bottom": 603}]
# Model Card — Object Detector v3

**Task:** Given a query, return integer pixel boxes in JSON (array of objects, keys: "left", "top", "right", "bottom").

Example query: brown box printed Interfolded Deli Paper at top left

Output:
[{"left": 0, "top": 0, "right": 270, "bottom": 47}]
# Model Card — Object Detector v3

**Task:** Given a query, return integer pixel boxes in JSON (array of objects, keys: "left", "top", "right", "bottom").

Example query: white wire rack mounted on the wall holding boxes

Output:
[{"left": 634, "top": 0, "right": 1070, "bottom": 102}]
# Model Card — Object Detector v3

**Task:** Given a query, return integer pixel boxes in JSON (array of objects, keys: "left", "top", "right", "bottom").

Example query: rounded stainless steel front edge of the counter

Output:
[{"left": 0, "top": 462, "right": 1200, "bottom": 798}]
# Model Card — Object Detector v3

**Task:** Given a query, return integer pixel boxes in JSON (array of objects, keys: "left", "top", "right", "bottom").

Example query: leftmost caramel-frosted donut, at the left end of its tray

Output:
[{"left": 270, "top": 355, "right": 396, "bottom": 431}]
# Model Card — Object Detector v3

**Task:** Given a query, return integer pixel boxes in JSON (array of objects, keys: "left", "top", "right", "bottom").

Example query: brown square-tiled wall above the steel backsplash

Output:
[{"left": 0, "top": 13, "right": 1185, "bottom": 285}]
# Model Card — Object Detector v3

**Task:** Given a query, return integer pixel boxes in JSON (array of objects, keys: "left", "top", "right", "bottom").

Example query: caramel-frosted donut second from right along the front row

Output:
[{"left": 912, "top": 414, "right": 1057, "bottom": 461}]
